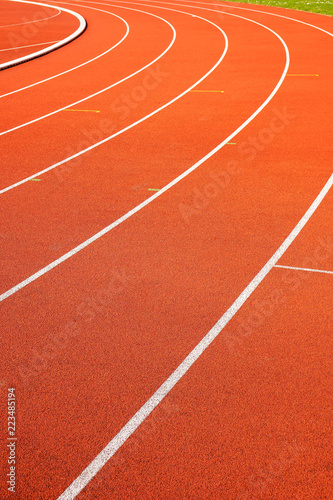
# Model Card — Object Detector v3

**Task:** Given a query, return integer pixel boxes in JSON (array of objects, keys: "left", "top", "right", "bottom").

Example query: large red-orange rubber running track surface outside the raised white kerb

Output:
[{"left": 0, "top": 2, "right": 333, "bottom": 500}]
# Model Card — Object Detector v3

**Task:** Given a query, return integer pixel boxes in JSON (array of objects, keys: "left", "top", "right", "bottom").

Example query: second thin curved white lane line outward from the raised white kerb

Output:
[{"left": 0, "top": 2, "right": 176, "bottom": 137}]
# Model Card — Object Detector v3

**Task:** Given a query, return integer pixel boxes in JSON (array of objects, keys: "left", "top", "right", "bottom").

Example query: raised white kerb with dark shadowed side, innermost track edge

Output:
[{"left": 0, "top": 0, "right": 87, "bottom": 70}]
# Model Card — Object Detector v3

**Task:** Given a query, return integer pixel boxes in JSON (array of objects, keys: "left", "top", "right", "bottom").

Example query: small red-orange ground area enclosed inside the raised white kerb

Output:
[{"left": 0, "top": 1, "right": 79, "bottom": 64}]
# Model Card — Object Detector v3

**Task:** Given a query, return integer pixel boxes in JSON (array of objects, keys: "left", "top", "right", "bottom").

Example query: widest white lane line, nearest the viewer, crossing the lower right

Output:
[{"left": 58, "top": 174, "right": 333, "bottom": 500}]
